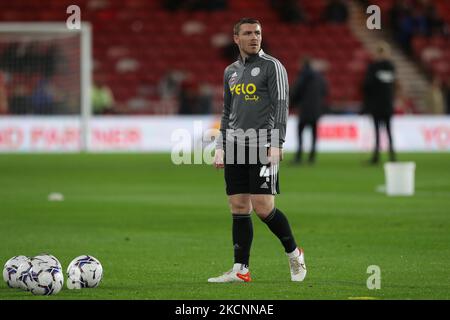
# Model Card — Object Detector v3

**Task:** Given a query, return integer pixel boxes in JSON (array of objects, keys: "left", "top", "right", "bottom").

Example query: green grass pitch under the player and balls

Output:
[{"left": 0, "top": 154, "right": 450, "bottom": 299}]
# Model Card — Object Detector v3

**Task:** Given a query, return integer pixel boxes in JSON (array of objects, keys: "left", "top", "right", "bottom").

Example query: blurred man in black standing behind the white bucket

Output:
[{"left": 363, "top": 42, "right": 396, "bottom": 164}]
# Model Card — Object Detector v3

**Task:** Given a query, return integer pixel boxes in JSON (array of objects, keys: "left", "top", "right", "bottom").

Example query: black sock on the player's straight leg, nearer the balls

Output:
[{"left": 233, "top": 213, "right": 253, "bottom": 267}]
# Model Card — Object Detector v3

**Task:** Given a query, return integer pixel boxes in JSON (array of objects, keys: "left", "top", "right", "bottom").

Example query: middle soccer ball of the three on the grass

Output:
[{"left": 28, "top": 264, "right": 64, "bottom": 296}]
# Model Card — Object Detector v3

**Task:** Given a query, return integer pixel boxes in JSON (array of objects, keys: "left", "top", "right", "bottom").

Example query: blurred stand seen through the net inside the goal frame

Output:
[{"left": 0, "top": 39, "right": 80, "bottom": 114}]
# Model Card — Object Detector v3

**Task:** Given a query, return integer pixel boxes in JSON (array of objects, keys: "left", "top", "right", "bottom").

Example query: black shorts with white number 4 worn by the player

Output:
[{"left": 224, "top": 146, "right": 280, "bottom": 196}]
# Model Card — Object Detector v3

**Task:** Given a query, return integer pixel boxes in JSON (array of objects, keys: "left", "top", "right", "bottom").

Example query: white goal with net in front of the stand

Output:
[{"left": 0, "top": 22, "right": 93, "bottom": 151}]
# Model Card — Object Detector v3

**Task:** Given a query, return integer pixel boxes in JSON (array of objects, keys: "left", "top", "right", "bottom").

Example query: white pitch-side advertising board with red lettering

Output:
[{"left": 0, "top": 115, "right": 450, "bottom": 154}]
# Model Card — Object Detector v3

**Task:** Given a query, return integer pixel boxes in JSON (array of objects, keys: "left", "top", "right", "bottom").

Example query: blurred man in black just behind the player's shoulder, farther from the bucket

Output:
[{"left": 291, "top": 58, "right": 328, "bottom": 164}]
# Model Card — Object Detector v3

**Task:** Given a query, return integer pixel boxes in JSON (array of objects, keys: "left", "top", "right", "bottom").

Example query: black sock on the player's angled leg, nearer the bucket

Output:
[{"left": 262, "top": 208, "right": 297, "bottom": 253}]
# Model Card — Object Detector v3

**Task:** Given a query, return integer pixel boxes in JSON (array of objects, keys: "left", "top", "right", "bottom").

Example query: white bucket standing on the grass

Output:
[{"left": 384, "top": 162, "right": 416, "bottom": 196}]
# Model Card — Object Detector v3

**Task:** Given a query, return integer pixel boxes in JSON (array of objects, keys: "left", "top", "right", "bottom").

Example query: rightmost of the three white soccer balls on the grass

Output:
[{"left": 67, "top": 255, "right": 103, "bottom": 289}]
